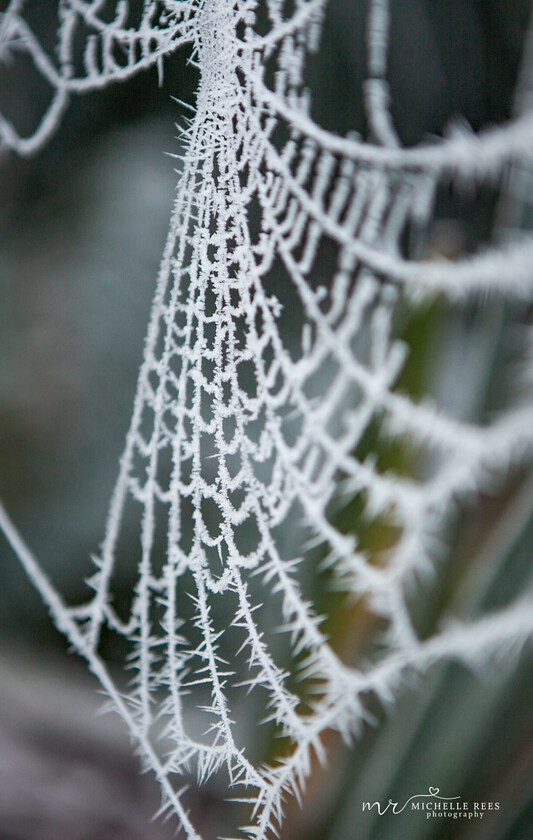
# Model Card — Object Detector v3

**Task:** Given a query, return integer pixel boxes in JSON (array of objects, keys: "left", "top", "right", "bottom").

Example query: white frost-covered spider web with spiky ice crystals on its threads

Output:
[{"left": 0, "top": 0, "right": 533, "bottom": 840}]
